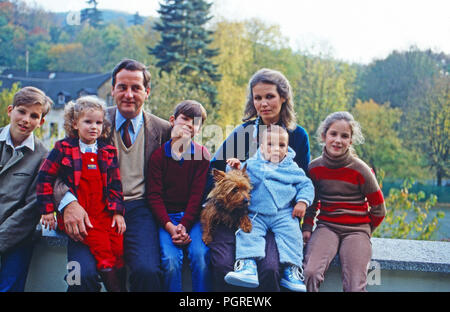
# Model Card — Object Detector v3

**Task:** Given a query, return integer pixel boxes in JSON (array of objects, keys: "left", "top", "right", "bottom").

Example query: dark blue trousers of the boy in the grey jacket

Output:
[{"left": 0, "top": 238, "right": 34, "bottom": 292}]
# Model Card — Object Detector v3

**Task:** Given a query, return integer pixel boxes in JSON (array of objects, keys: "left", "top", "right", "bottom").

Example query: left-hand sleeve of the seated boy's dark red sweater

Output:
[{"left": 147, "top": 145, "right": 170, "bottom": 227}]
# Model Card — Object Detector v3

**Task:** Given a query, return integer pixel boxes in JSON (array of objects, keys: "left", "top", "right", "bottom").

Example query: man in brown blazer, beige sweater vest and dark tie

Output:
[{"left": 55, "top": 59, "right": 171, "bottom": 291}]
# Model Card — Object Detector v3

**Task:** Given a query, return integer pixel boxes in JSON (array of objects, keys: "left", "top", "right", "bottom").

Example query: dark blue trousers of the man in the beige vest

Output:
[{"left": 67, "top": 200, "right": 162, "bottom": 292}]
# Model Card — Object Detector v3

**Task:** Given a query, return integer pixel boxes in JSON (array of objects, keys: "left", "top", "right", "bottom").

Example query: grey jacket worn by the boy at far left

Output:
[{"left": 0, "top": 128, "right": 48, "bottom": 254}]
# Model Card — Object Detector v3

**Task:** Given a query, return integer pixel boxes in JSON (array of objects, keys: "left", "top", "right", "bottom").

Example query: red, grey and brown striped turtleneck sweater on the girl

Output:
[{"left": 302, "top": 148, "right": 386, "bottom": 235}]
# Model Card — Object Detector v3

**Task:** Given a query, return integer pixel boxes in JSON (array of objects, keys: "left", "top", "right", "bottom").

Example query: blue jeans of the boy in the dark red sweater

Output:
[{"left": 159, "top": 212, "right": 211, "bottom": 292}]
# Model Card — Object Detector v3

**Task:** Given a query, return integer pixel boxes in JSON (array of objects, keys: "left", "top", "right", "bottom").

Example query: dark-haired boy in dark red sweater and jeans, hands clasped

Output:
[{"left": 147, "top": 100, "right": 211, "bottom": 292}]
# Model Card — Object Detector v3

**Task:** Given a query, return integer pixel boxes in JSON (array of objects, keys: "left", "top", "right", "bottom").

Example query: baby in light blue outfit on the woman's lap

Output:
[{"left": 225, "top": 125, "right": 314, "bottom": 291}]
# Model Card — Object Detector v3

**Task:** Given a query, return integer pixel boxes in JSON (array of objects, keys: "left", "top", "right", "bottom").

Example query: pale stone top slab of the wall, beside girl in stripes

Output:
[{"left": 331, "top": 238, "right": 450, "bottom": 273}]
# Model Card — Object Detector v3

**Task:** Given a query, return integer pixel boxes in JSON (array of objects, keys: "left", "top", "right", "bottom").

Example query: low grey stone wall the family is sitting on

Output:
[{"left": 25, "top": 238, "right": 450, "bottom": 292}]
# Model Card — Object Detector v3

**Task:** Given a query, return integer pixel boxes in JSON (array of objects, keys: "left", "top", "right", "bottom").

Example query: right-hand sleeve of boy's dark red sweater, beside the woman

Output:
[{"left": 180, "top": 146, "right": 210, "bottom": 231}]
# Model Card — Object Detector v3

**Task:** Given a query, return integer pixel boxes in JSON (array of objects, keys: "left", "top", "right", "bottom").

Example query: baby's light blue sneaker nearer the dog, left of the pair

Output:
[{"left": 225, "top": 259, "right": 259, "bottom": 288}]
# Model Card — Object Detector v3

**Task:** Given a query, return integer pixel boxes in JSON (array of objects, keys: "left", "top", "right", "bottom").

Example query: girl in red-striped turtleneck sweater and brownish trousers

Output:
[{"left": 302, "top": 112, "right": 386, "bottom": 291}]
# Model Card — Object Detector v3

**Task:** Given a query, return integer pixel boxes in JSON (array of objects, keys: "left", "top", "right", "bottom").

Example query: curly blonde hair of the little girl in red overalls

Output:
[{"left": 64, "top": 95, "right": 111, "bottom": 139}]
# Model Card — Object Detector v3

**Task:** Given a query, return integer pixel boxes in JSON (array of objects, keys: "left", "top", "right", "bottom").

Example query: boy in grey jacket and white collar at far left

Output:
[{"left": 0, "top": 87, "right": 53, "bottom": 292}]
